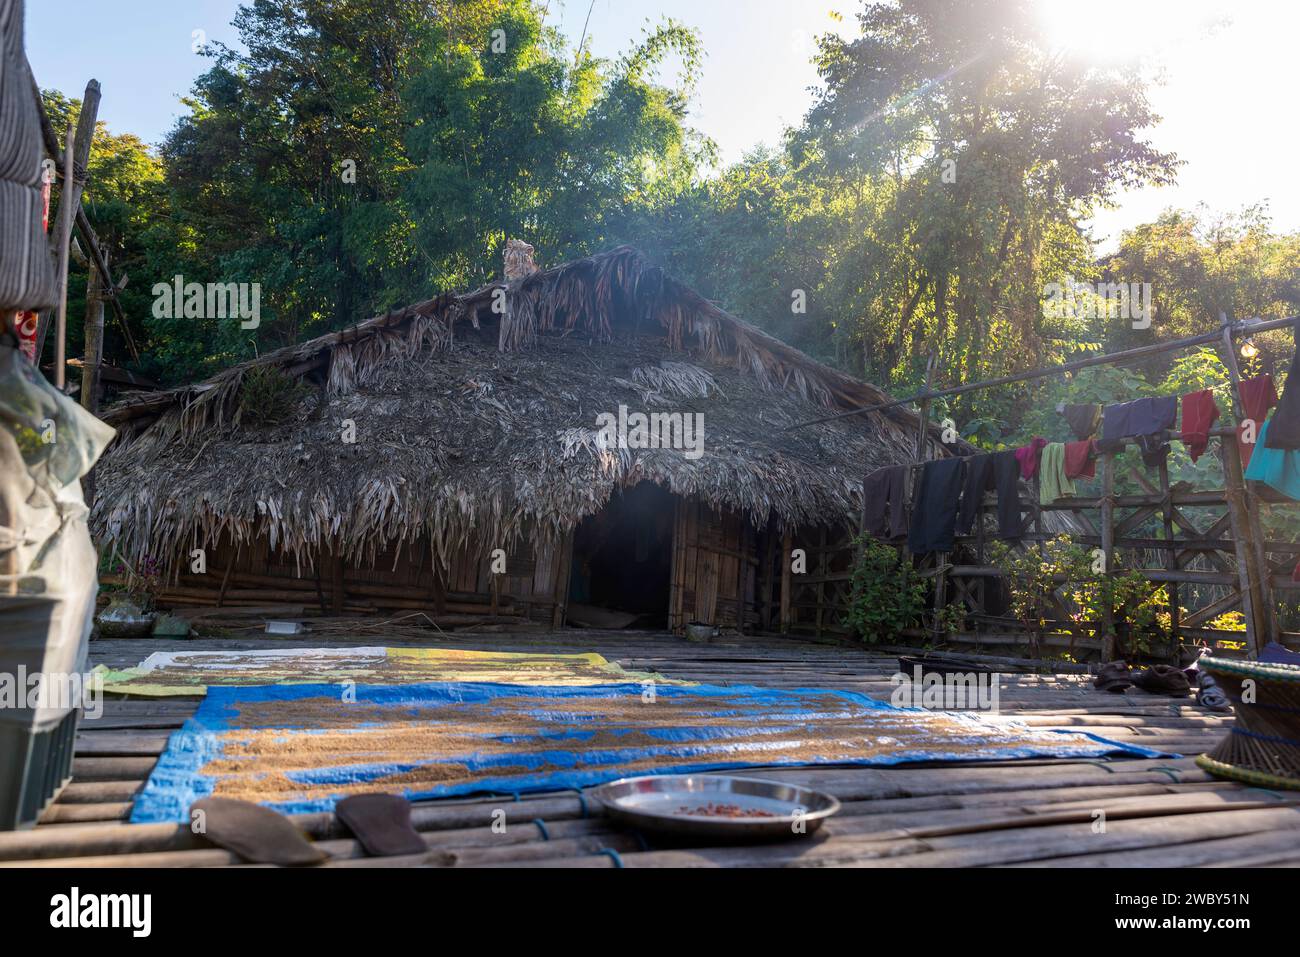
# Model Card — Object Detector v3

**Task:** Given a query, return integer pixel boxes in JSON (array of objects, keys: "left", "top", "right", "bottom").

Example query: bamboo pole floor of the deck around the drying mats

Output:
[{"left": 0, "top": 631, "right": 1300, "bottom": 867}]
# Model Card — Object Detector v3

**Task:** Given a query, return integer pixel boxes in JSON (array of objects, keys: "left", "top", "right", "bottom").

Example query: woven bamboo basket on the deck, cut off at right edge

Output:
[{"left": 1196, "top": 658, "right": 1300, "bottom": 791}]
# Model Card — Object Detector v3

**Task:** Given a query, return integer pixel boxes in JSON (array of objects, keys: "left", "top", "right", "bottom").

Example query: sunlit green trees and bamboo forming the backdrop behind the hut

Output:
[{"left": 47, "top": 0, "right": 1300, "bottom": 434}]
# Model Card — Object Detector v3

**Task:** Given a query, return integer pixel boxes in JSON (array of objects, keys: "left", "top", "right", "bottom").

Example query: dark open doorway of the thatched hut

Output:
[{"left": 568, "top": 482, "right": 673, "bottom": 629}]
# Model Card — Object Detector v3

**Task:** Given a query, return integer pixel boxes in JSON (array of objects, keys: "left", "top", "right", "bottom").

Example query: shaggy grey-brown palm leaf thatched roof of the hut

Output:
[{"left": 92, "top": 247, "right": 946, "bottom": 566}]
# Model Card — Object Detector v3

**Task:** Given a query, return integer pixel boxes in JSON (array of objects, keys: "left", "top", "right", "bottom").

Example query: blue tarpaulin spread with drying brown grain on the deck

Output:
[{"left": 131, "top": 683, "right": 1164, "bottom": 823}]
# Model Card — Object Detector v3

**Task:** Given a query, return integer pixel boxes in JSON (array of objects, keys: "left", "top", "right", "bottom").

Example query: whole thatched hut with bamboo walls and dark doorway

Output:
[{"left": 94, "top": 248, "right": 945, "bottom": 628}]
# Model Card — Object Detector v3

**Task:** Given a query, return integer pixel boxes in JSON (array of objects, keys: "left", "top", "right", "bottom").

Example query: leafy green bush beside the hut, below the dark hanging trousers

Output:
[{"left": 844, "top": 536, "right": 928, "bottom": 644}]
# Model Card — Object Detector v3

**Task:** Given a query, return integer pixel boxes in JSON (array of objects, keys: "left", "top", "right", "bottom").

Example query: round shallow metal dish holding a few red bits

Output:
[{"left": 593, "top": 774, "right": 840, "bottom": 841}]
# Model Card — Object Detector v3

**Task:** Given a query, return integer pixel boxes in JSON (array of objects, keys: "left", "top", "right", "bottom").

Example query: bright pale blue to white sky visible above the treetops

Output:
[{"left": 20, "top": 0, "right": 1300, "bottom": 247}]
